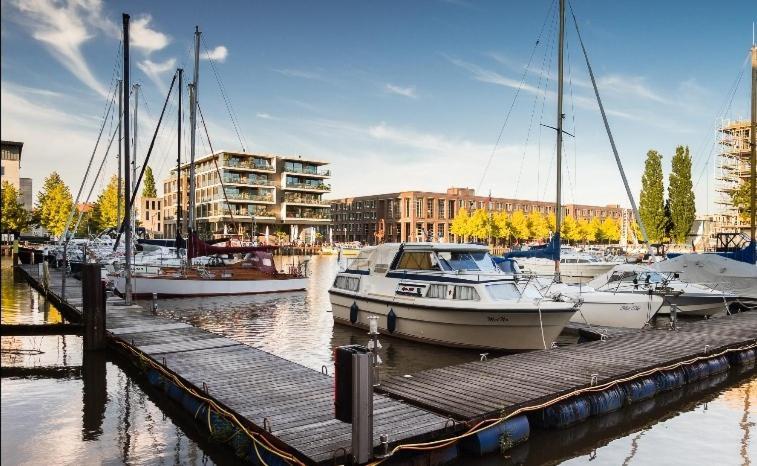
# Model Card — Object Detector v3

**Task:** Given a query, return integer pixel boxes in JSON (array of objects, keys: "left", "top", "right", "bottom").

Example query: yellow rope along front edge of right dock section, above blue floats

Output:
[{"left": 368, "top": 342, "right": 757, "bottom": 466}]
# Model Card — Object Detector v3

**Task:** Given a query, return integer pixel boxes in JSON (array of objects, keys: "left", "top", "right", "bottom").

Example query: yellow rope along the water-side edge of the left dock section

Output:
[{"left": 114, "top": 340, "right": 305, "bottom": 466}]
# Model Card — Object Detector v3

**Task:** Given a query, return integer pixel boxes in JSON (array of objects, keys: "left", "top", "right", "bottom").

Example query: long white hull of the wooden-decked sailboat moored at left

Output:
[{"left": 114, "top": 275, "right": 307, "bottom": 297}]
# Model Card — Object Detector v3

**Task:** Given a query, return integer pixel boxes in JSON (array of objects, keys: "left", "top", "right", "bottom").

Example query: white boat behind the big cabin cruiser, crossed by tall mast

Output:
[{"left": 518, "top": 246, "right": 618, "bottom": 283}]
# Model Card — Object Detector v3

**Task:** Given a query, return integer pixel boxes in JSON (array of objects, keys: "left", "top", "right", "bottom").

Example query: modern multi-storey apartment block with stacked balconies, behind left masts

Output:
[{"left": 163, "top": 151, "right": 331, "bottom": 240}]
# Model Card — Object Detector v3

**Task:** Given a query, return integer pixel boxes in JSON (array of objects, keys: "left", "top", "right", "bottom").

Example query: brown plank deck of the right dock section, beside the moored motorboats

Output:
[{"left": 380, "top": 312, "right": 757, "bottom": 421}]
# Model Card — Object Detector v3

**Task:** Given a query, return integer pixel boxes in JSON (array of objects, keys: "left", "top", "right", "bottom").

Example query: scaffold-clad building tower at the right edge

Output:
[{"left": 715, "top": 120, "right": 751, "bottom": 231}]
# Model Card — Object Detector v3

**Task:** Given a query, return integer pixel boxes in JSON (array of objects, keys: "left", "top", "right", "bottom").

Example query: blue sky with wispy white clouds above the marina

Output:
[{"left": 0, "top": 0, "right": 757, "bottom": 214}]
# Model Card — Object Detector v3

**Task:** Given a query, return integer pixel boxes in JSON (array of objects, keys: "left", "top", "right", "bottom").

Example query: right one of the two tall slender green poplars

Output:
[{"left": 668, "top": 146, "right": 696, "bottom": 243}]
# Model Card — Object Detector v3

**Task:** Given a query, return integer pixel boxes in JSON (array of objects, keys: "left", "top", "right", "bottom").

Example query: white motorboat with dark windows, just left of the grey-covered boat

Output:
[{"left": 587, "top": 264, "right": 735, "bottom": 316}]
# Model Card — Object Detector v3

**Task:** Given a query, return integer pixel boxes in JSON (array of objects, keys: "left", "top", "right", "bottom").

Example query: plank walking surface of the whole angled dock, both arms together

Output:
[{"left": 11, "top": 266, "right": 757, "bottom": 464}]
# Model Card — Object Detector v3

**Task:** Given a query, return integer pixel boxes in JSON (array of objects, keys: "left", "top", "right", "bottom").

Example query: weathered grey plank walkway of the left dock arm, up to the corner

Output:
[{"left": 14, "top": 266, "right": 449, "bottom": 464}]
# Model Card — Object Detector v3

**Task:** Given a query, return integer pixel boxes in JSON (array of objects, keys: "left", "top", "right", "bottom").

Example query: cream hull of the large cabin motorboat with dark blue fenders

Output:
[{"left": 329, "top": 291, "right": 575, "bottom": 351}]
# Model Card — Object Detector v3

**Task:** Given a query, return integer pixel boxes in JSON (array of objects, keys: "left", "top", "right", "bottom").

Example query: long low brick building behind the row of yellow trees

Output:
[{"left": 330, "top": 188, "right": 623, "bottom": 244}]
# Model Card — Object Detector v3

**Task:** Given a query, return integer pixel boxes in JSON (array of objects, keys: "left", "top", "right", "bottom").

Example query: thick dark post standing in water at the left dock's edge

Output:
[{"left": 81, "top": 264, "right": 105, "bottom": 351}]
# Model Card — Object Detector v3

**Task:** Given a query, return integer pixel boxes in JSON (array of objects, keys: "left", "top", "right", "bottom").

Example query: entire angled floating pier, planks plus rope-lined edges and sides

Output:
[{"left": 10, "top": 265, "right": 757, "bottom": 464}]
